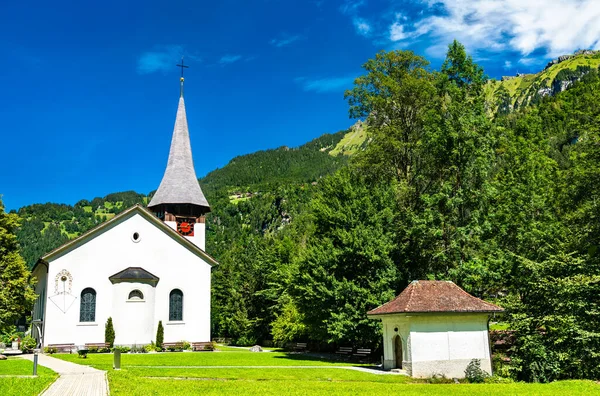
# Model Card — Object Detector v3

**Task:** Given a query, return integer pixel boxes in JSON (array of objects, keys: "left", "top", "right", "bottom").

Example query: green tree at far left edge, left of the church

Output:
[{"left": 0, "top": 196, "right": 36, "bottom": 332}]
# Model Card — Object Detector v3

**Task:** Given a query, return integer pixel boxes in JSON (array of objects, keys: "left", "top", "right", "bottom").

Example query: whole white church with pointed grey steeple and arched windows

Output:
[{"left": 32, "top": 72, "right": 218, "bottom": 347}]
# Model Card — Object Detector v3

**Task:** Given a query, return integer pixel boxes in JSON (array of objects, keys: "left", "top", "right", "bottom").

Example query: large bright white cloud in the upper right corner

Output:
[{"left": 388, "top": 0, "right": 600, "bottom": 57}]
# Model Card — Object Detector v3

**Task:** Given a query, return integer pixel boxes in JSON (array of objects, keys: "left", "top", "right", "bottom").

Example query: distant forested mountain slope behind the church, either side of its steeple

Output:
[{"left": 17, "top": 130, "right": 356, "bottom": 267}]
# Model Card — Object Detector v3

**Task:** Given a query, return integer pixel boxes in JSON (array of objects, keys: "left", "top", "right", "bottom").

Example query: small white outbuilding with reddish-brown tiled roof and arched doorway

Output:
[{"left": 367, "top": 280, "right": 504, "bottom": 378}]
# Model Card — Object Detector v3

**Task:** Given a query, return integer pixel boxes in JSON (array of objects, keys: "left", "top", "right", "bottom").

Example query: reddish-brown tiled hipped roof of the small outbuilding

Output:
[{"left": 367, "top": 280, "right": 504, "bottom": 315}]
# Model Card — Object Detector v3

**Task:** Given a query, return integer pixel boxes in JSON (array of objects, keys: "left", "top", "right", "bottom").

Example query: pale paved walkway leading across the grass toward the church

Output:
[{"left": 23, "top": 354, "right": 108, "bottom": 396}]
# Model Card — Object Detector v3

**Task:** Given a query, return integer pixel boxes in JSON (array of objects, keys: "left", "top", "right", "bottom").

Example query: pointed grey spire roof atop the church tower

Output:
[{"left": 148, "top": 95, "right": 210, "bottom": 212}]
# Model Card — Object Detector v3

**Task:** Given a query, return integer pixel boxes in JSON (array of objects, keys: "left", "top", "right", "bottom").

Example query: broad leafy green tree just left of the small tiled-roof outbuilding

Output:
[{"left": 292, "top": 169, "right": 406, "bottom": 346}]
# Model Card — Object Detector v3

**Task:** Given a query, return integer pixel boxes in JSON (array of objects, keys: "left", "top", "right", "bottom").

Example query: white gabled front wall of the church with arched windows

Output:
[{"left": 44, "top": 212, "right": 210, "bottom": 345}]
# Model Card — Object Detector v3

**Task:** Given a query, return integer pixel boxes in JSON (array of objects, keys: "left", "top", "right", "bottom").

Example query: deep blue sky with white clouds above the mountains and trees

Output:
[{"left": 0, "top": 0, "right": 600, "bottom": 209}]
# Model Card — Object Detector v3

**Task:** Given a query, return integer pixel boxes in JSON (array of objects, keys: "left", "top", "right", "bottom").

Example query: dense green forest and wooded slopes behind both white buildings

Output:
[{"left": 5, "top": 42, "right": 600, "bottom": 382}]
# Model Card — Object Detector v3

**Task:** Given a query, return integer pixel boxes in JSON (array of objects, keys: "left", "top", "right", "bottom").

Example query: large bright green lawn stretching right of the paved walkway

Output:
[{"left": 54, "top": 348, "right": 600, "bottom": 396}]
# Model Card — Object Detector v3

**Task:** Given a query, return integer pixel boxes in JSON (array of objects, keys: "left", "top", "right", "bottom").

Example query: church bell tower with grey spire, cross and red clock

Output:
[{"left": 148, "top": 58, "right": 210, "bottom": 250}]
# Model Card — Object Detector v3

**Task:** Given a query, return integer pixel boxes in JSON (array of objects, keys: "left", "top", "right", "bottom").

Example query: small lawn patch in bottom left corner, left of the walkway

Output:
[{"left": 0, "top": 358, "right": 58, "bottom": 396}]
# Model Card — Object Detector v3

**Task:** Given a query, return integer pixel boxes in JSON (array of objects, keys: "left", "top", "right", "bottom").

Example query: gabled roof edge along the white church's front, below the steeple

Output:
[{"left": 32, "top": 204, "right": 219, "bottom": 271}]
